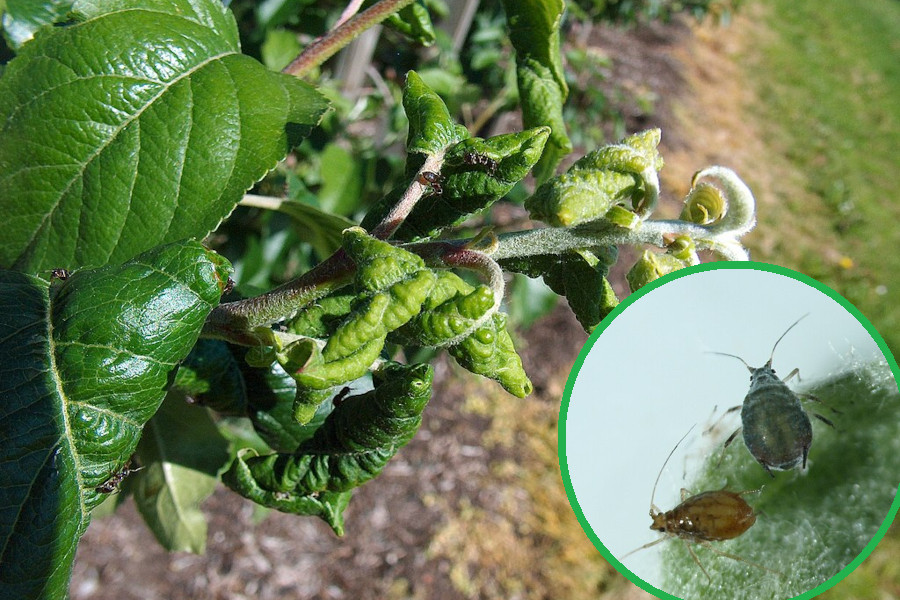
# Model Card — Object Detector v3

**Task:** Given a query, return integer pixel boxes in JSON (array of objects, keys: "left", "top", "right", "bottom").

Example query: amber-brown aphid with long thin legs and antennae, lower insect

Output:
[{"left": 622, "top": 427, "right": 781, "bottom": 582}]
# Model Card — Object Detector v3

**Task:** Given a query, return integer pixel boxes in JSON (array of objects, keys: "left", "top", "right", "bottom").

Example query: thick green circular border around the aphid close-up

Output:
[{"left": 557, "top": 261, "right": 900, "bottom": 600}]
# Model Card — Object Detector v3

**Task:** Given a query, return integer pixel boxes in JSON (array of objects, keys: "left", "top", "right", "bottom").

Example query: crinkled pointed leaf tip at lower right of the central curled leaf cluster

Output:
[{"left": 447, "top": 313, "right": 534, "bottom": 398}]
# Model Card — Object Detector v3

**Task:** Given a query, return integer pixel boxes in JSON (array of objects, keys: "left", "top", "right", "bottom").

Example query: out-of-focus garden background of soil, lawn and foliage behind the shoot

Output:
[{"left": 71, "top": 0, "right": 900, "bottom": 600}]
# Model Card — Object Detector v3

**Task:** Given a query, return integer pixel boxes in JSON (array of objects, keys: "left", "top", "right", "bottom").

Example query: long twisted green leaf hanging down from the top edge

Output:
[{"left": 503, "top": 0, "right": 572, "bottom": 182}]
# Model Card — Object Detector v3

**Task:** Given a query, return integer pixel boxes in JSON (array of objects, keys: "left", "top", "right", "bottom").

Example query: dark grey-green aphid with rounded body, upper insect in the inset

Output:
[{"left": 711, "top": 315, "right": 834, "bottom": 477}]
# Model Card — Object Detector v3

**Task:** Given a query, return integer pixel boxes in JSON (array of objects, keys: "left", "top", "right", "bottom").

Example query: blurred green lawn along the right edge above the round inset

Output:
[{"left": 742, "top": 0, "right": 900, "bottom": 351}]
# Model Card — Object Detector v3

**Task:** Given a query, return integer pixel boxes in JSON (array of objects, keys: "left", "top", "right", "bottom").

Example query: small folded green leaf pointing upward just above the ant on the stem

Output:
[{"left": 403, "top": 71, "right": 469, "bottom": 154}]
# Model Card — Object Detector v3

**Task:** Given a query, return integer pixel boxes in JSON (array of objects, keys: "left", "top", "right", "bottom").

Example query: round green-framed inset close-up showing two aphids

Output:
[{"left": 559, "top": 263, "right": 900, "bottom": 599}]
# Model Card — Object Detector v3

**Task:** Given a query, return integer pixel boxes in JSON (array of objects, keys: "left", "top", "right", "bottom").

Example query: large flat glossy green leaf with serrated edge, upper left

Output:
[{"left": 0, "top": 0, "right": 327, "bottom": 272}]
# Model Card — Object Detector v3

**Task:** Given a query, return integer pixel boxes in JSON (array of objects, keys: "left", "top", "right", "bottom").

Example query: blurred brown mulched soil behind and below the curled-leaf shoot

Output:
[{"left": 71, "top": 14, "right": 734, "bottom": 600}]
